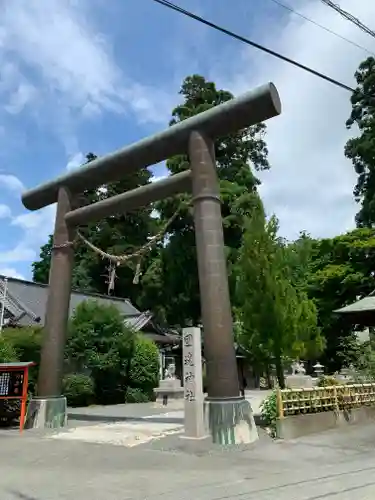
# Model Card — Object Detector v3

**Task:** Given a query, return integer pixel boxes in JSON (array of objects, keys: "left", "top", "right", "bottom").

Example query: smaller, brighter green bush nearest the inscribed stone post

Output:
[{"left": 128, "top": 335, "right": 159, "bottom": 401}]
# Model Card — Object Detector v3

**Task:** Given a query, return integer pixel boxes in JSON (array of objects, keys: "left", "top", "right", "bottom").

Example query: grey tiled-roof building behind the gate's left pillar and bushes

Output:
[{"left": 0, "top": 275, "right": 180, "bottom": 371}]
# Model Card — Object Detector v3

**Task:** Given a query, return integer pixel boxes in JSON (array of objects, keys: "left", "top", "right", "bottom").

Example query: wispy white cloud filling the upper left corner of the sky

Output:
[{"left": 0, "top": 0, "right": 174, "bottom": 134}]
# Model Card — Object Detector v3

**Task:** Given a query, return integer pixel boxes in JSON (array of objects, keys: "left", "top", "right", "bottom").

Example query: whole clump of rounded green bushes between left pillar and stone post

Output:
[{"left": 66, "top": 300, "right": 159, "bottom": 404}]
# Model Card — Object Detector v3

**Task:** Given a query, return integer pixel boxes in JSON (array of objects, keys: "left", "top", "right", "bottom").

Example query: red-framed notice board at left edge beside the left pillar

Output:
[{"left": 0, "top": 361, "right": 35, "bottom": 432}]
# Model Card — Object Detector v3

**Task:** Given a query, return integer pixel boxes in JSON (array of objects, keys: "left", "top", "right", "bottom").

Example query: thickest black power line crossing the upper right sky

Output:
[{"left": 152, "top": 0, "right": 354, "bottom": 92}]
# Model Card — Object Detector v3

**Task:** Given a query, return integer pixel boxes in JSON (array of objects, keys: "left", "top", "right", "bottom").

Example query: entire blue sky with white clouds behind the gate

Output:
[{"left": 0, "top": 0, "right": 375, "bottom": 278}]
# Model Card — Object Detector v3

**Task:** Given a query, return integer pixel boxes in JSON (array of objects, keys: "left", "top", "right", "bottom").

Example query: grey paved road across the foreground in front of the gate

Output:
[{"left": 0, "top": 420, "right": 375, "bottom": 500}]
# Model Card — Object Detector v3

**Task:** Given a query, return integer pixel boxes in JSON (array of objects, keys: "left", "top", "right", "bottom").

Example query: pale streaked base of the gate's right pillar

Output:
[{"left": 205, "top": 397, "right": 259, "bottom": 445}]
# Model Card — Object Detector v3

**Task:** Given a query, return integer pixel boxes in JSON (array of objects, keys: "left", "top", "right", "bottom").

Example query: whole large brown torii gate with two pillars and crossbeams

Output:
[{"left": 22, "top": 83, "right": 281, "bottom": 442}]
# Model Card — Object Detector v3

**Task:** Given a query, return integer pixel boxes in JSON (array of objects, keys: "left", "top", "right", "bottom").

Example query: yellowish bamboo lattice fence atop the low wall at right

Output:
[{"left": 277, "top": 383, "right": 375, "bottom": 418}]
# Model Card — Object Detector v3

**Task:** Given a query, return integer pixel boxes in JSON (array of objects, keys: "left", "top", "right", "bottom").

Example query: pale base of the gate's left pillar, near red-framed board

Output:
[{"left": 25, "top": 396, "right": 68, "bottom": 429}]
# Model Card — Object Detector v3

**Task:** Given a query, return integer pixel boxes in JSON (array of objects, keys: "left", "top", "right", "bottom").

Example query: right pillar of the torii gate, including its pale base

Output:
[{"left": 189, "top": 131, "right": 258, "bottom": 444}]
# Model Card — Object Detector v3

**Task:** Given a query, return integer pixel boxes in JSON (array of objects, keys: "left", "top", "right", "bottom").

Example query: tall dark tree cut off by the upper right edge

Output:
[{"left": 345, "top": 57, "right": 375, "bottom": 227}]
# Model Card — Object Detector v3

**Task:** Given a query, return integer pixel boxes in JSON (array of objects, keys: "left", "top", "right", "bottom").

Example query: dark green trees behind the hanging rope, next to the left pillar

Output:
[{"left": 32, "top": 153, "right": 157, "bottom": 303}]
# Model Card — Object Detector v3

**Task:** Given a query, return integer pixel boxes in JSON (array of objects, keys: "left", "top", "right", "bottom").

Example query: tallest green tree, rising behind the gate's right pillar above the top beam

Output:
[{"left": 142, "top": 75, "right": 269, "bottom": 325}]
